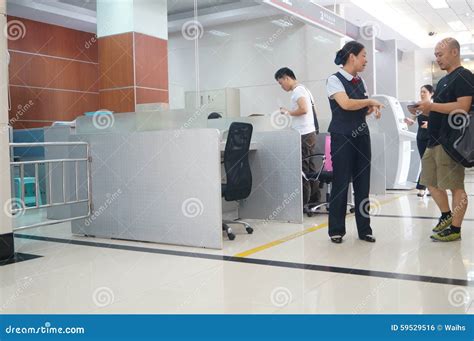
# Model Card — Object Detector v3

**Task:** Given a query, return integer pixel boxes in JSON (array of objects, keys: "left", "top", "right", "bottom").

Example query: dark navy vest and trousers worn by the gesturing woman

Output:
[{"left": 328, "top": 72, "right": 372, "bottom": 239}]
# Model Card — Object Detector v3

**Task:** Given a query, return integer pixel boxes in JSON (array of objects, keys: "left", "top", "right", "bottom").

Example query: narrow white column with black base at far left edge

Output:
[{"left": 0, "top": 0, "right": 14, "bottom": 260}]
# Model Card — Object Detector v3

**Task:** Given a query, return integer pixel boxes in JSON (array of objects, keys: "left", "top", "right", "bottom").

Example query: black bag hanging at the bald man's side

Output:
[{"left": 440, "top": 110, "right": 474, "bottom": 168}]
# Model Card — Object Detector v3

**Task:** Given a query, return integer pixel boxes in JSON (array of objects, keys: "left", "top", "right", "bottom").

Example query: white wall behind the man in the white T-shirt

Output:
[{"left": 168, "top": 16, "right": 340, "bottom": 130}]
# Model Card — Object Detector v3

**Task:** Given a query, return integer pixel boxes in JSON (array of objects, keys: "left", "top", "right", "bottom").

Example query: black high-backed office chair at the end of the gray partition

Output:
[{"left": 221, "top": 122, "right": 253, "bottom": 240}]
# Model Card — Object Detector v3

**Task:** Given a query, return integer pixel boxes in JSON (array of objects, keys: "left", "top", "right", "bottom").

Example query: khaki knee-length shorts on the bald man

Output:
[{"left": 420, "top": 145, "right": 464, "bottom": 190}]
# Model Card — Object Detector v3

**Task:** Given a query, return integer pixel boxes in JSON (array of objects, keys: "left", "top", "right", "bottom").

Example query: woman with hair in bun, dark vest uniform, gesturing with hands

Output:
[{"left": 327, "top": 41, "right": 382, "bottom": 244}]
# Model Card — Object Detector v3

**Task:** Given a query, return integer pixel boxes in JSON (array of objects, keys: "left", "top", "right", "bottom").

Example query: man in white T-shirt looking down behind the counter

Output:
[{"left": 275, "top": 67, "right": 320, "bottom": 205}]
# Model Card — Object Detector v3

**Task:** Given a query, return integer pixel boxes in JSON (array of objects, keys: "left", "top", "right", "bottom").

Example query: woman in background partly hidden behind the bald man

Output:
[{"left": 405, "top": 84, "right": 434, "bottom": 198}]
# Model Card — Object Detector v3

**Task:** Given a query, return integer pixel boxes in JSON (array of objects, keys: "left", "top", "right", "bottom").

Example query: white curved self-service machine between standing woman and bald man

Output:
[{"left": 367, "top": 95, "right": 416, "bottom": 189}]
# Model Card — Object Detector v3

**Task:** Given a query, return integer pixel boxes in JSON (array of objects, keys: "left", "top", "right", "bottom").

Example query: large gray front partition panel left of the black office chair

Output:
[{"left": 72, "top": 129, "right": 222, "bottom": 249}]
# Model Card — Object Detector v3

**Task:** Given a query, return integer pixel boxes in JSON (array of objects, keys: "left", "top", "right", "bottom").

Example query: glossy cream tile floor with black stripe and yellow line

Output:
[{"left": 0, "top": 172, "right": 474, "bottom": 314}]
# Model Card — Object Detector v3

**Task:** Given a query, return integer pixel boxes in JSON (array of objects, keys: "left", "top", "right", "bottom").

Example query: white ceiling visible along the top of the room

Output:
[{"left": 7, "top": 0, "right": 474, "bottom": 51}]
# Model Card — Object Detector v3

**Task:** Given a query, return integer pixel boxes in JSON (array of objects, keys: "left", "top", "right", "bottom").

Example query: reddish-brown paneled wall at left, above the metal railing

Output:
[{"left": 8, "top": 17, "right": 99, "bottom": 128}]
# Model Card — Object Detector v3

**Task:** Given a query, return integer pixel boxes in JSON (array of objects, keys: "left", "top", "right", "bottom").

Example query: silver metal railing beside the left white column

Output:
[{"left": 10, "top": 142, "right": 92, "bottom": 231}]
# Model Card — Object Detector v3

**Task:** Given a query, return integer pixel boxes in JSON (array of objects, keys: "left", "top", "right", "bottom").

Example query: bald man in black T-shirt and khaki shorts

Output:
[{"left": 415, "top": 38, "right": 474, "bottom": 242}]
